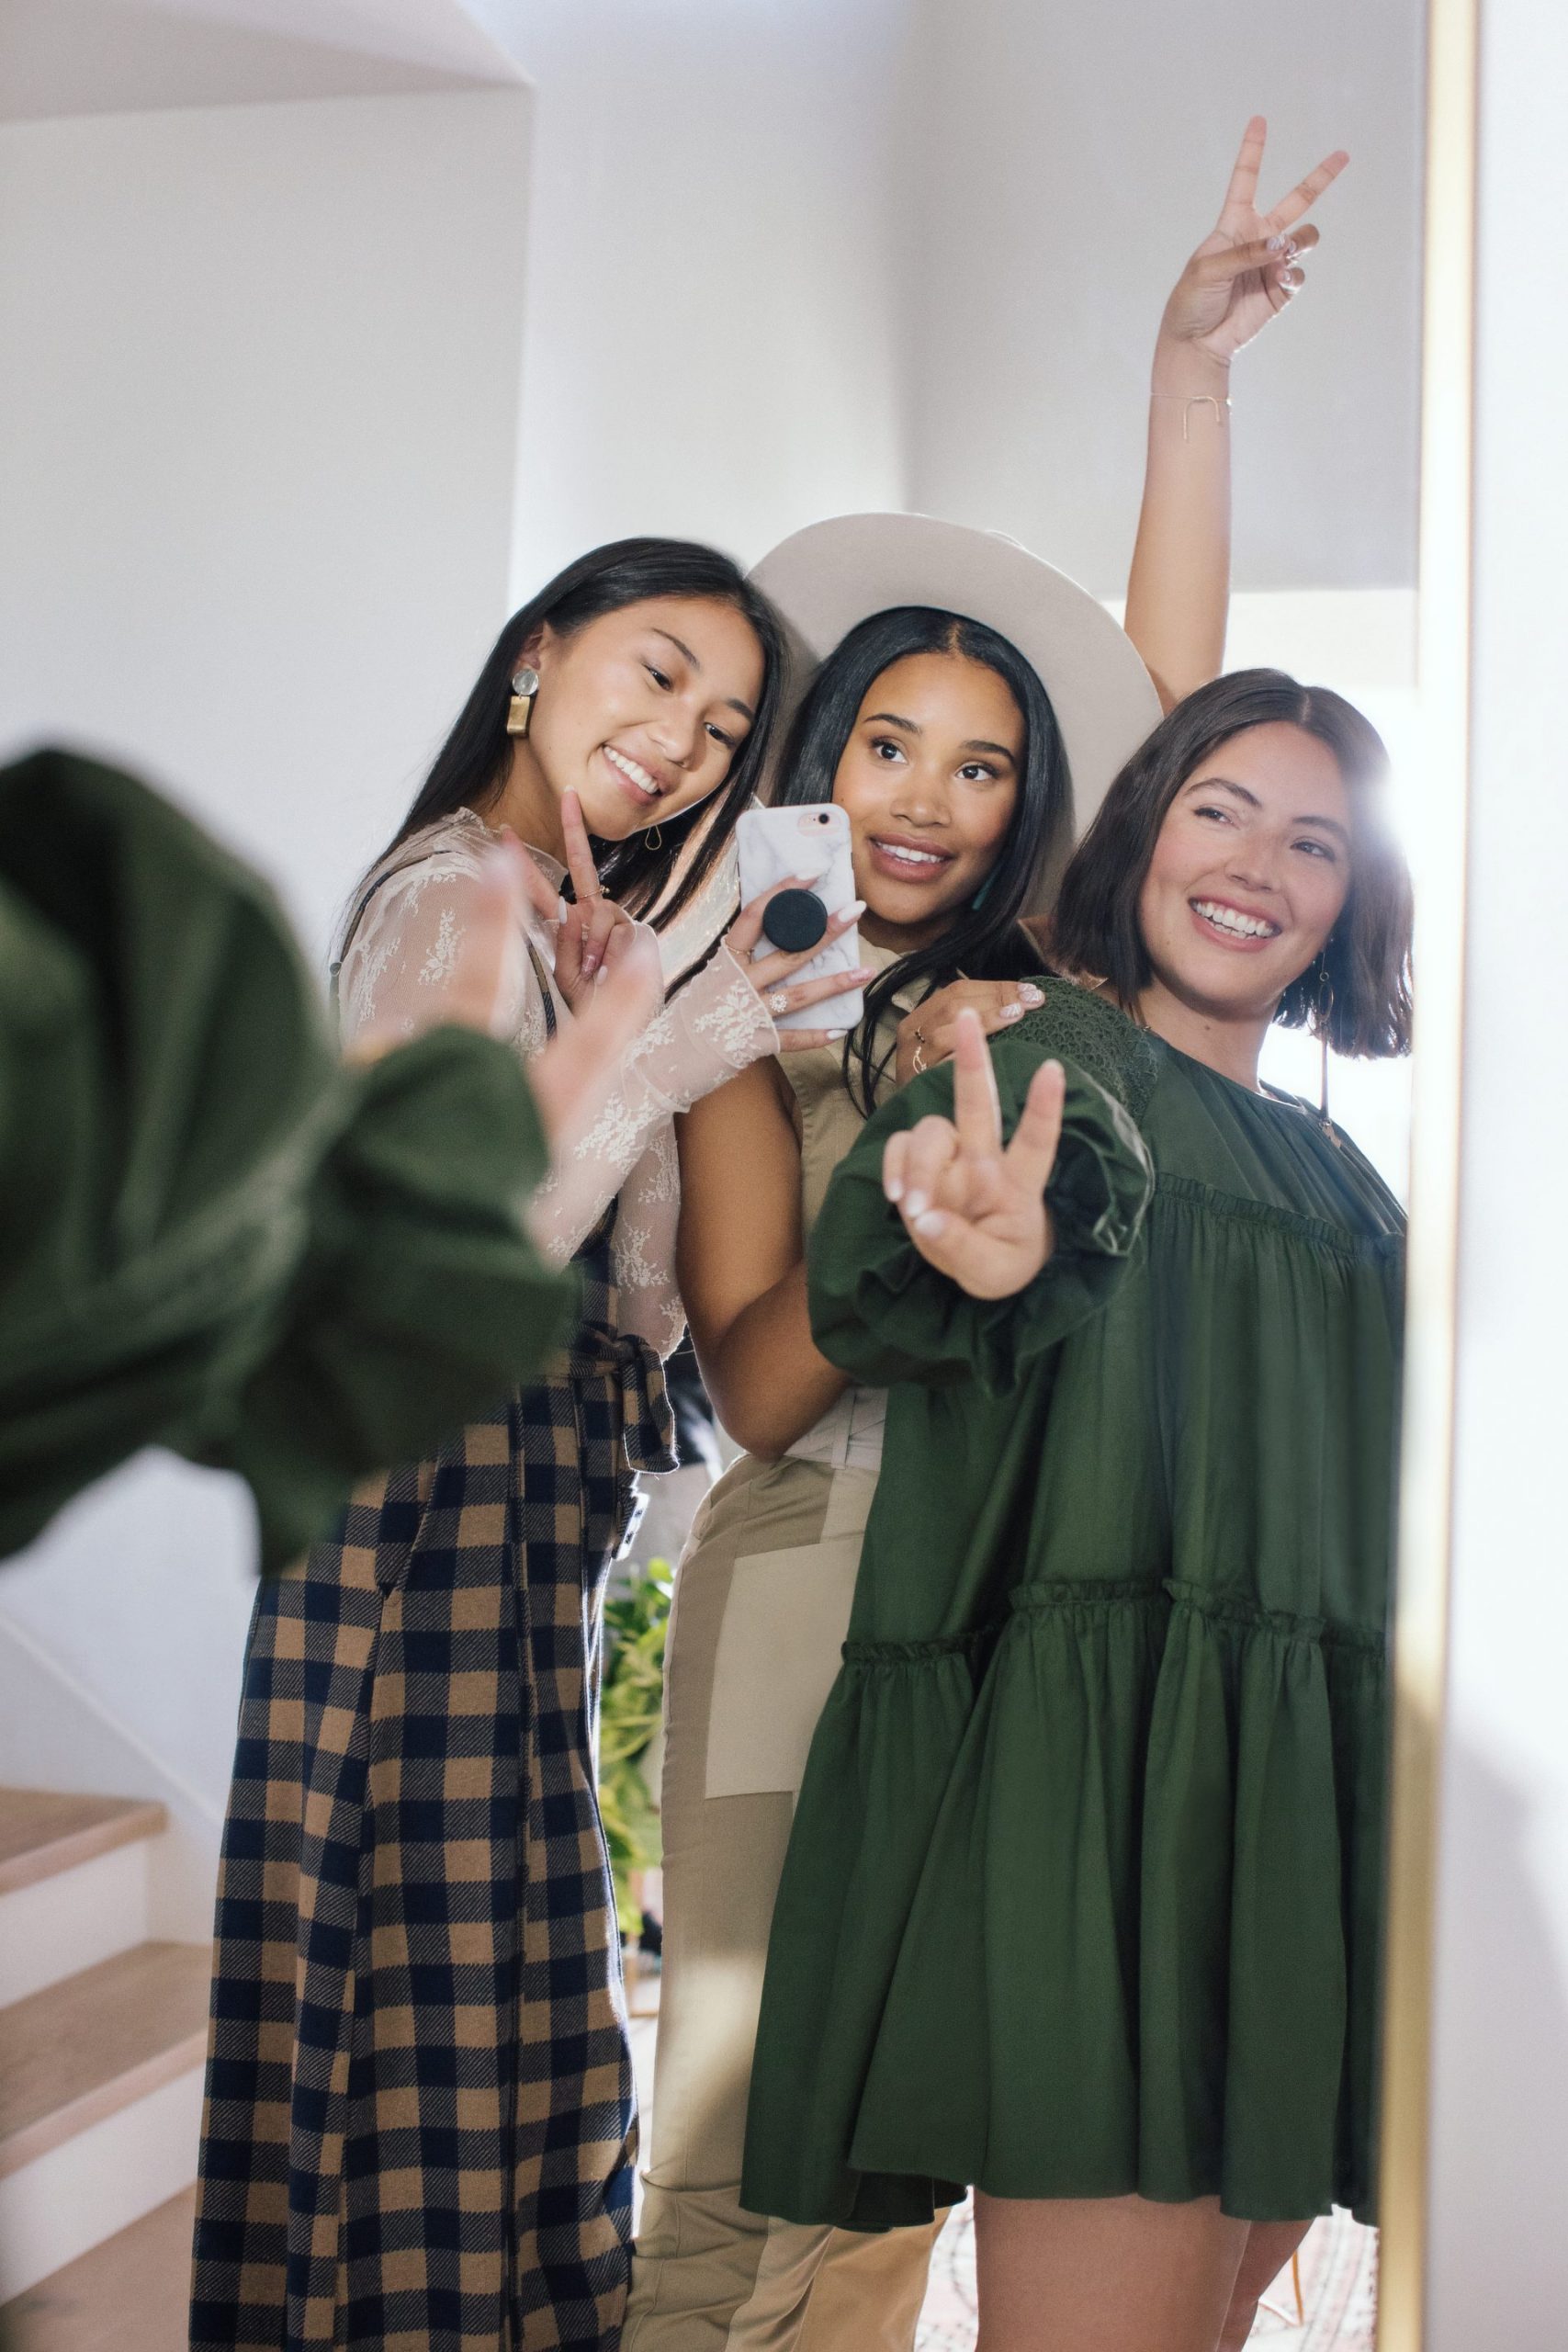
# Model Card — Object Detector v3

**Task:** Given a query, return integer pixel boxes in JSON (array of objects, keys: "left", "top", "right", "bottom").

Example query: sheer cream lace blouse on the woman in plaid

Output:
[{"left": 339, "top": 809, "right": 778, "bottom": 1355}]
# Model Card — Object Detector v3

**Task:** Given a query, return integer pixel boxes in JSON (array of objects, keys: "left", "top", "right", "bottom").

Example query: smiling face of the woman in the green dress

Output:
[{"left": 1138, "top": 722, "right": 1352, "bottom": 1025}]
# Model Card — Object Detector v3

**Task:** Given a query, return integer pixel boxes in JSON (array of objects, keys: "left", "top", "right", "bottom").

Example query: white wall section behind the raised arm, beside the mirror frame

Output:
[{"left": 898, "top": 0, "right": 1425, "bottom": 595}]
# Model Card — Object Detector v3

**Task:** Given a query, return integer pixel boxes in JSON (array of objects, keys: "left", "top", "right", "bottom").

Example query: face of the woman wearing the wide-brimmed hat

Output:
[{"left": 832, "top": 654, "right": 1025, "bottom": 953}]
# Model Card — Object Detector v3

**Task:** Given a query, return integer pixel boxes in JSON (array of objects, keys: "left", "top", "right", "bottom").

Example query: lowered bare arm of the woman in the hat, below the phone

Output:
[{"left": 677, "top": 1063, "right": 849, "bottom": 1461}]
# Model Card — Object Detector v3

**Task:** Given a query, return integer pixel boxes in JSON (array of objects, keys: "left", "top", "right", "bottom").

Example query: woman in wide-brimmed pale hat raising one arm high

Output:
[{"left": 623, "top": 122, "right": 1345, "bottom": 2352}]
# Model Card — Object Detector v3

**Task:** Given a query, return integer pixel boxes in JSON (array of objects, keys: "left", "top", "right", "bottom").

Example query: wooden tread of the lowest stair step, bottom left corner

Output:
[{"left": 0, "top": 2189, "right": 195, "bottom": 2352}]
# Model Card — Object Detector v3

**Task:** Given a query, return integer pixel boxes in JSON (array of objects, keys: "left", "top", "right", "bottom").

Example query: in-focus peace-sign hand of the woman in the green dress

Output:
[{"left": 882, "top": 1007, "right": 1067, "bottom": 1298}]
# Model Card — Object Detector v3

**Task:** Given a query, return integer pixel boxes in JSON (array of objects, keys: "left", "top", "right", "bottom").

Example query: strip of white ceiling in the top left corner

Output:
[{"left": 0, "top": 0, "right": 520, "bottom": 122}]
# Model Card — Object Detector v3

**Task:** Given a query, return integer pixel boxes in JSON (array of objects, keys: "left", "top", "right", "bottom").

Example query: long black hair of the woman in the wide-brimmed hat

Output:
[{"left": 773, "top": 605, "right": 1072, "bottom": 1113}]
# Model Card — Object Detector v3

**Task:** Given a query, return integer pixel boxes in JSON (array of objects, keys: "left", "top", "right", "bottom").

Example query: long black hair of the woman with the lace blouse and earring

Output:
[{"left": 364, "top": 538, "right": 787, "bottom": 929}]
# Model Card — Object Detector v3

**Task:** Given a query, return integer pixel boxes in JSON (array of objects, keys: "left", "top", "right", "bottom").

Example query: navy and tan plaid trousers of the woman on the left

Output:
[{"left": 190, "top": 1232, "right": 672, "bottom": 2352}]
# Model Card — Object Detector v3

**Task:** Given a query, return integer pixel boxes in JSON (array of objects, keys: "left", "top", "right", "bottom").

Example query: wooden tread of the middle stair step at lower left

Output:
[{"left": 0, "top": 1943, "right": 211, "bottom": 2178}]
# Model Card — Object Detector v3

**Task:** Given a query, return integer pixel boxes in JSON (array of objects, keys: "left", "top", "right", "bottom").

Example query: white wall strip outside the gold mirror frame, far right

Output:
[{"left": 1427, "top": 0, "right": 1568, "bottom": 2352}]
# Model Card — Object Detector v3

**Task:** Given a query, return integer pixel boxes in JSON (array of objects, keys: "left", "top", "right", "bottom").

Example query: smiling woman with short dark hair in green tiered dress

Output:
[{"left": 743, "top": 671, "right": 1411, "bottom": 2352}]
